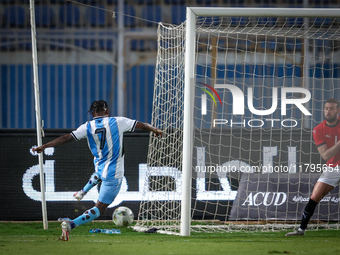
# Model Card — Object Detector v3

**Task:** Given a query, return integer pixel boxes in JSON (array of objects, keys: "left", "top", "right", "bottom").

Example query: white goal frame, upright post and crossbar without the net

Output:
[{"left": 180, "top": 7, "right": 340, "bottom": 236}]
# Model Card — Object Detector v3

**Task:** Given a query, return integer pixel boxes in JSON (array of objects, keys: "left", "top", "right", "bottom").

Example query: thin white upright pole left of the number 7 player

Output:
[{"left": 30, "top": 0, "right": 48, "bottom": 230}]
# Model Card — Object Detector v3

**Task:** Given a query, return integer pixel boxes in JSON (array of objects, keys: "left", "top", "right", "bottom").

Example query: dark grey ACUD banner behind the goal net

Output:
[{"left": 229, "top": 173, "right": 340, "bottom": 221}]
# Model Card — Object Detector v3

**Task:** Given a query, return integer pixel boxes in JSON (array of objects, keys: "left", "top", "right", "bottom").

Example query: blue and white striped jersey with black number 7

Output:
[{"left": 71, "top": 117, "right": 137, "bottom": 179}]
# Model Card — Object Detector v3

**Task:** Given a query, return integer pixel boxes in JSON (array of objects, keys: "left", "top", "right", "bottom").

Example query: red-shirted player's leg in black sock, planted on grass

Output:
[{"left": 286, "top": 178, "right": 334, "bottom": 236}]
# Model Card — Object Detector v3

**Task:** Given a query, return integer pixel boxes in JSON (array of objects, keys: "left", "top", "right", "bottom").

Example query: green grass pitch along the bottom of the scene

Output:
[{"left": 0, "top": 222, "right": 340, "bottom": 255}]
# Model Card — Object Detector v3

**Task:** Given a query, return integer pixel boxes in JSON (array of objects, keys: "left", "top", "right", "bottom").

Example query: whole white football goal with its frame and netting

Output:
[{"left": 135, "top": 8, "right": 340, "bottom": 235}]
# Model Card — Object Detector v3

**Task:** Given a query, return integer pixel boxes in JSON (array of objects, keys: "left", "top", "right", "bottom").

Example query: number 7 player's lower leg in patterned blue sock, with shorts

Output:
[{"left": 60, "top": 179, "right": 122, "bottom": 241}]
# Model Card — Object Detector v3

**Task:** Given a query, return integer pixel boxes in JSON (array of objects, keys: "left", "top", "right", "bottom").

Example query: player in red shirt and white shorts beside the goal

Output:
[{"left": 286, "top": 98, "right": 340, "bottom": 236}]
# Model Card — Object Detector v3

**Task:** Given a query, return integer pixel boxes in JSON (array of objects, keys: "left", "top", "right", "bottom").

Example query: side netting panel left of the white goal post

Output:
[{"left": 137, "top": 24, "right": 185, "bottom": 234}]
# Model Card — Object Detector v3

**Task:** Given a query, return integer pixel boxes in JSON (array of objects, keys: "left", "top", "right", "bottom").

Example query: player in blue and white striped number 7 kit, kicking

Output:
[{"left": 33, "top": 100, "right": 162, "bottom": 241}]
